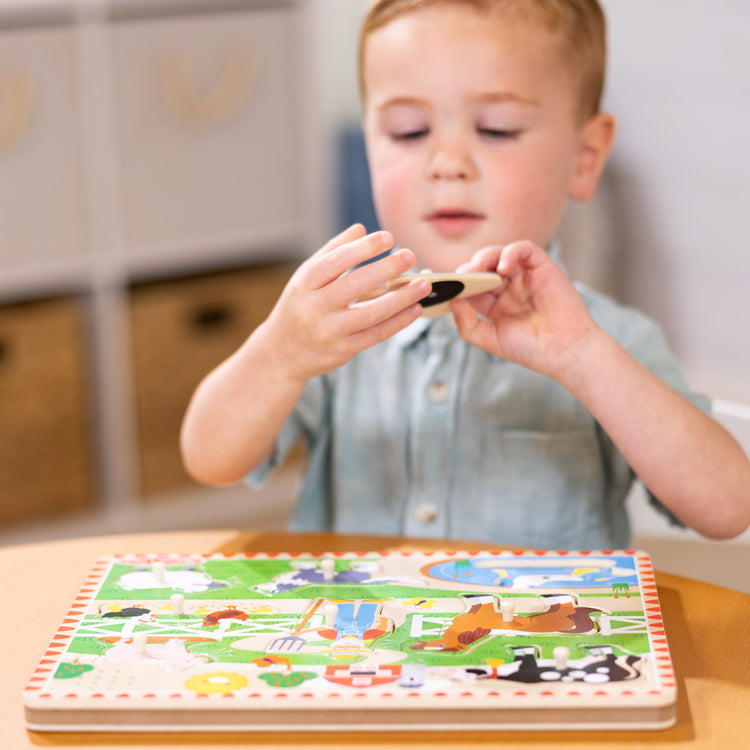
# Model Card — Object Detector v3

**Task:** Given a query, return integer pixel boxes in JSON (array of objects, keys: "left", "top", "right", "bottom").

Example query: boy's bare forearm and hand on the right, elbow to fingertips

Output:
[{"left": 453, "top": 242, "right": 750, "bottom": 539}]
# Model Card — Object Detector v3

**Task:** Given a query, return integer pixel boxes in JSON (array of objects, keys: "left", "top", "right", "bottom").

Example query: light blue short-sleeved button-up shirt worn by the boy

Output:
[{"left": 248, "top": 266, "right": 709, "bottom": 549}]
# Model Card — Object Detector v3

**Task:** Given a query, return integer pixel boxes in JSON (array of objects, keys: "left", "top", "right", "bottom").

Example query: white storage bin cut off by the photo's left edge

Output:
[{"left": 0, "top": 26, "right": 87, "bottom": 271}]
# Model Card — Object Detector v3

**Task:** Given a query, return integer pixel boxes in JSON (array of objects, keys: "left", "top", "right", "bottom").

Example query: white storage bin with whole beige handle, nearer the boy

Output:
[{"left": 113, "top": 5, "right": 300, "bottom": 257}]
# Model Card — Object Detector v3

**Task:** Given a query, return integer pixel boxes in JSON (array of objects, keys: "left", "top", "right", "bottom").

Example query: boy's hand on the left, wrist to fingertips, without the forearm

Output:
[{"left": 258, "top": 224, "right": 430, "bottom": 381}]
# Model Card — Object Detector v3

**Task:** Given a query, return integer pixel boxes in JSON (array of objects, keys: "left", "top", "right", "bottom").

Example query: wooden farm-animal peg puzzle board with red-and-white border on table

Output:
[{"left": 24, "top": 552, "right": 676, "bottom": 731}]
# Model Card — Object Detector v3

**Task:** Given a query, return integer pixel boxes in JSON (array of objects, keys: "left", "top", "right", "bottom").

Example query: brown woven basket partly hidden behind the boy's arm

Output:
[{"left": 130, "top": 265, "right": 291, "bottom": 499}]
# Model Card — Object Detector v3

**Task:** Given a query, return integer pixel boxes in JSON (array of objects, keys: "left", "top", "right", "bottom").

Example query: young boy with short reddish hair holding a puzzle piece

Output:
[{"left": 182, "top": 0, "right": 750, "bottom": 549}]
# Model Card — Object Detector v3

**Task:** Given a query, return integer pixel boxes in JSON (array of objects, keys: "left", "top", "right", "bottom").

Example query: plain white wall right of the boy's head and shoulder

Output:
[{"left": 604, "top": 0, "right": 750, "bottom": 403}]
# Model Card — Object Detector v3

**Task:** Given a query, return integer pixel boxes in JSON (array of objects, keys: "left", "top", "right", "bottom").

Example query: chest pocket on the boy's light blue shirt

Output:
[{"left": 467, "top": 426, "right": 607, "bottom": 549}]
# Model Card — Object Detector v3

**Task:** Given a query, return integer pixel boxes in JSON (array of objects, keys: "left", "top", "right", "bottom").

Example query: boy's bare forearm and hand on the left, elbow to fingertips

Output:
[{"left": 180, "top": 225, "right": 430, "bottom": 486}]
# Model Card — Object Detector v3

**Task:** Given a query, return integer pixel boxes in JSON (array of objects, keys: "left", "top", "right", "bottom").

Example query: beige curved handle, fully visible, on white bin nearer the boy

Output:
[{"left": 158, "top": 51, "right": 257, "bottom": 129}]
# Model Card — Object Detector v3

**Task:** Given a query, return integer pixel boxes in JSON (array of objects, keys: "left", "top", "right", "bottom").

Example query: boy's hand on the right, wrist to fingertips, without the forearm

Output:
[{"left": 453, "top": 242, "right": 599, "bottom": 380}]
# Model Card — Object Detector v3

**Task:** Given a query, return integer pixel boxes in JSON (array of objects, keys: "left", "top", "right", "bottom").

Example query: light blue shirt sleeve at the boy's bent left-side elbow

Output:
[{"left": 244, "top": 377, "right": 329, "bottom": 488}]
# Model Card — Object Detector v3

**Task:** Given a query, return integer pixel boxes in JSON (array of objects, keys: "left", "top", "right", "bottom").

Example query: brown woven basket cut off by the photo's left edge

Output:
[{"left": 0, "top": 298, "right": 94, "bottom": 524}]
